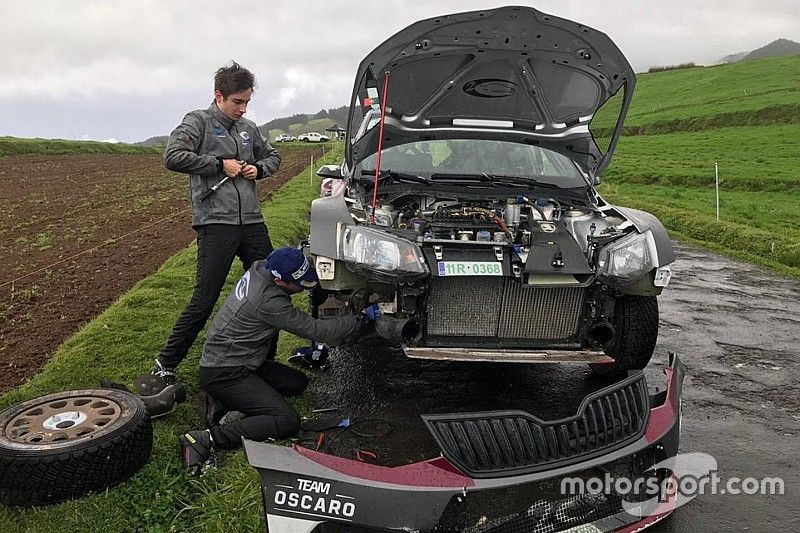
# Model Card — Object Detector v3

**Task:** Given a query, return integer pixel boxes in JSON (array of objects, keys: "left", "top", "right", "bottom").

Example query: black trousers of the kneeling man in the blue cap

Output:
[{"left": 200, "top": 360, "right": 308, "bottom": 450}]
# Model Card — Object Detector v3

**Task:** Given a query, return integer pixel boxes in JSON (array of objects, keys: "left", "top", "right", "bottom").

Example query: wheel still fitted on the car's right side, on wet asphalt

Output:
[{"left": 589, "top": 296, "right": 658, "bottom": 376}]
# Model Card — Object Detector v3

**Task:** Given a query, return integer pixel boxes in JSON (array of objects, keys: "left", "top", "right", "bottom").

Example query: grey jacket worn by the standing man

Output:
[{"left": 164, "top": 102, "right": 281, "bottom": 226}]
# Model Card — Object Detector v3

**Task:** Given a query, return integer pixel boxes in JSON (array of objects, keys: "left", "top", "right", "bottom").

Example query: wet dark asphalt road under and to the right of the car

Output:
[{"left": 313, "top": 243, "right": 800, "bottom": 532}]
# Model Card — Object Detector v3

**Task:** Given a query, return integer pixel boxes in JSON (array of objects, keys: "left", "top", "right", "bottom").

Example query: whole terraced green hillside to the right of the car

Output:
[{"left": 592, "top": 54, "right": 800, "bottom": 277}]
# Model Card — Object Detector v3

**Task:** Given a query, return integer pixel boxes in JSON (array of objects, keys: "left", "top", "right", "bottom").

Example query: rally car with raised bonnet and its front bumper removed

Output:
[{"left": 310, "top": 7, "right": 674, "bottom": 372}]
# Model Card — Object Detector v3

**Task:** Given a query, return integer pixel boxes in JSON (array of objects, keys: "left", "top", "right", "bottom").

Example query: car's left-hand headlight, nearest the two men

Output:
[{"left": 341, "top": 226, "right": 429, "bottom": 276}]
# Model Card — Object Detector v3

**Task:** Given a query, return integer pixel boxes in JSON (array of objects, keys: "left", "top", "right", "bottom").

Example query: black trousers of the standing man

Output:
[{"left": 159, "top": 223, "right": 277, "bottom": 368}]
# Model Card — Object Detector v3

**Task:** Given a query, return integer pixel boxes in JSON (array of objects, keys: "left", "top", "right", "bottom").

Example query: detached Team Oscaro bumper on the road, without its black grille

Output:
[{"left": 245, "top": 356, "right": 685, "bottom": 533}]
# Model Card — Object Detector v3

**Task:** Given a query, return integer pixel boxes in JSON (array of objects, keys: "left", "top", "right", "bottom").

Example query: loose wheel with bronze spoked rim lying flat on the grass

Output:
[{"left": 0, "top": 389, "right": 153, "bottom": 505}]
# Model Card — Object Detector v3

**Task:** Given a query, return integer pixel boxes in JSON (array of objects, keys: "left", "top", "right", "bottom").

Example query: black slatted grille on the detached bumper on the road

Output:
[{"left": 423, "top": 373, "right": 650, "bottom": 477}]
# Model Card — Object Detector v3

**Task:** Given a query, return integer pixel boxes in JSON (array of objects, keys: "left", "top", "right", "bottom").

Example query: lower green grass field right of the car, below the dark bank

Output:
[{"left": 600, "top": 124, "right": 800, "bottom": 278}]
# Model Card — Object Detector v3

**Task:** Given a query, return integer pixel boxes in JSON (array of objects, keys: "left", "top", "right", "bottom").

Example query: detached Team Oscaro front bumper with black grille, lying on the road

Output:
[{"left": 244, "top": 356, "right": 685, "bottom": 533}]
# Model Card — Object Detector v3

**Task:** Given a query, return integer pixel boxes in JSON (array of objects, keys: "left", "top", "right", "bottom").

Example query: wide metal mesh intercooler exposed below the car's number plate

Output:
[{"left": 428, "top": 276, "right": 586, "bottom": 341}]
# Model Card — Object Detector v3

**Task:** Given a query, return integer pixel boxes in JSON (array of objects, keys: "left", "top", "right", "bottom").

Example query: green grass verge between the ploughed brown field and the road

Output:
[{"left": 0, "top": 146, "right": 341, "bottom": 532}]
